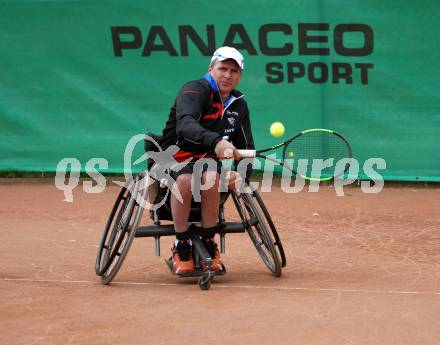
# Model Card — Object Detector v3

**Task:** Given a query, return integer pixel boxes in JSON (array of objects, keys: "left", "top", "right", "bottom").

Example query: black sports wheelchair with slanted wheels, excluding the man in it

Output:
[{"left": 95, "top": 133, "right": 286, "bottom": 290}]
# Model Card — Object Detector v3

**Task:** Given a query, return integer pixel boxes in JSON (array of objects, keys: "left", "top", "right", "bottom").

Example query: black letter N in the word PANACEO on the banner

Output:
[{"left": 179, "top": 25, "right": 215, "bottom": 56}]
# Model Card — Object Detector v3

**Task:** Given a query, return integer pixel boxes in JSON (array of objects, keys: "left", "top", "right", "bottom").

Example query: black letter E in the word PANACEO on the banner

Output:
[{"left": 298, "top": 23, "right": 330, "bottom": 55}]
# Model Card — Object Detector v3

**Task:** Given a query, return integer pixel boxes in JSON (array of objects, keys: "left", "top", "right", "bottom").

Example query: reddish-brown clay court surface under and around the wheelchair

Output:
[{"left": 0, "top": 181, "right": 440, "bottom": 345}]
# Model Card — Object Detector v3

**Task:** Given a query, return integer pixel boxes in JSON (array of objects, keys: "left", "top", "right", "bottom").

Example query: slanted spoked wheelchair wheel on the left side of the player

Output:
[{"left": 95, "top": 177, "right": 145, "bottom": 285}]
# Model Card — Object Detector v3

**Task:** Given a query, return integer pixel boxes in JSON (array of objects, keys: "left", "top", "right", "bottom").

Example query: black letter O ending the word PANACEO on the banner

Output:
[{"left": 333, "top": 24, "right": 374, "bottom": 56}]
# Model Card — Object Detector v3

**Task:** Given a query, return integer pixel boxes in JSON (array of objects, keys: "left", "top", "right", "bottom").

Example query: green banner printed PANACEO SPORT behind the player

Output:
[{"left": 0, "top": 0, "right": 440, "bottom": 181}]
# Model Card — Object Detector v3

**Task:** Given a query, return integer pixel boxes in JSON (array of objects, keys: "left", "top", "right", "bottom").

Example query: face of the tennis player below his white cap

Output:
[{"left": 208, "top": 59, "right": 241, "bottom": 96}]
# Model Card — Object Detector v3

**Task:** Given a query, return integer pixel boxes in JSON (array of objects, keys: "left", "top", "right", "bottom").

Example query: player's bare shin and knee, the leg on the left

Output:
[{"left": 171, "top": 174, "right": 192, "bottom": 232}]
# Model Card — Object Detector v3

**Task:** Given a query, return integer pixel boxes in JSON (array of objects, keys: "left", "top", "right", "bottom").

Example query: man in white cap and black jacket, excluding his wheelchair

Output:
[{"left": 160, "top": 47, "right": 255, "bottom": 274}]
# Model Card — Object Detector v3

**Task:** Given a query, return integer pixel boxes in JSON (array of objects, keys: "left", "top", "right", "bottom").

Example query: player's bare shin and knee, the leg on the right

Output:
[{"left": 200, "top": 171, "right": 220, "bottom": 228}]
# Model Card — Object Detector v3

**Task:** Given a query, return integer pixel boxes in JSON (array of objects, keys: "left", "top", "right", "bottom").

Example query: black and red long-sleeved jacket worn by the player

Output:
[{"left": 161, "top": 73, "right": 255, "bottom": 161}]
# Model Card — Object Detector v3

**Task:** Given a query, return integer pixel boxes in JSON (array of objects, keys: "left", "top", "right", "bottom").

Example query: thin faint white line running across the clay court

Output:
[{"left": 0, "top": 278, "right": 440, "bottom": 296}]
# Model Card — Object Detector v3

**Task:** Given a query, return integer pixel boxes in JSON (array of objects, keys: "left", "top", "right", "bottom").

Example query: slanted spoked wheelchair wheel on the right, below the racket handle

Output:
[{"left": 232, "top": 190, "right": 281, "bottom": 277}]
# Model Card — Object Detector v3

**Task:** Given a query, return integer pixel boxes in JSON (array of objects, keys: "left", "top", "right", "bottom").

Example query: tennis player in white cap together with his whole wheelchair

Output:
[{"left": 95, "top": 47, "right": 286, "bottom": 290}]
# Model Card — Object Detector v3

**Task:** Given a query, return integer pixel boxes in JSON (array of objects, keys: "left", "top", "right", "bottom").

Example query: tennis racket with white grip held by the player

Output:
[{"left": 238, "top": 128, "right": 352, "bottom": 181}]
